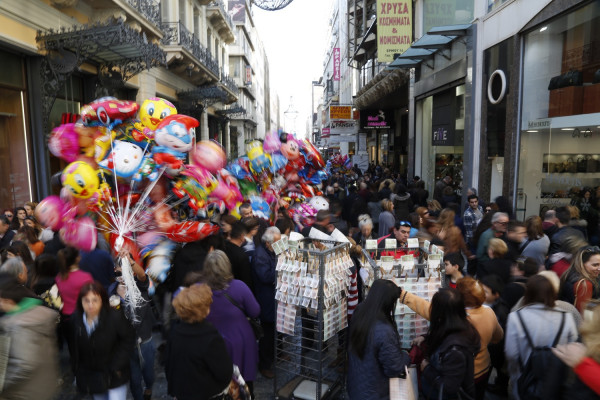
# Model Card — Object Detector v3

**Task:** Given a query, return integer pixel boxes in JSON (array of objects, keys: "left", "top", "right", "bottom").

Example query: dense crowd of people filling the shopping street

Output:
[{"left": 0, "top": 166, "right": 600, "bottom": 400}]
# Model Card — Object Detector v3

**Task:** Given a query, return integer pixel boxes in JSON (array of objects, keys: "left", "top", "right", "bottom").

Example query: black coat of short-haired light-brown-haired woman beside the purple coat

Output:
[{"left": 165, "top": 320, "right": 233, "bottom": 400}]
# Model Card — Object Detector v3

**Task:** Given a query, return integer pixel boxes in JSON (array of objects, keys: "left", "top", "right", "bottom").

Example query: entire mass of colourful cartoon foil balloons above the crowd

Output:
[{"left": 36, "top": 97, "right": 327, "bottom": 281}]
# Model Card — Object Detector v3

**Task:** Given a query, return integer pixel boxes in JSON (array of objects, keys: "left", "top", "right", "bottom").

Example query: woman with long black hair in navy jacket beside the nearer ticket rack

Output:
[{"left": 348, "top": 279, "right": 410, "bottom": 400}]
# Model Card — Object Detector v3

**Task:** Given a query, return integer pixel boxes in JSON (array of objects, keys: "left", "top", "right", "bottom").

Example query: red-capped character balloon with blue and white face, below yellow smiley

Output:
[{"left": 152, "top": 114, "right": 199, "bottom": 175}]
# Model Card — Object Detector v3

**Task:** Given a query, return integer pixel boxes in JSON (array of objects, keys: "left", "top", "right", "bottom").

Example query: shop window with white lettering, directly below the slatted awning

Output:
[{"left": 419, "top": 85, "right": 465, "bottom": 195}]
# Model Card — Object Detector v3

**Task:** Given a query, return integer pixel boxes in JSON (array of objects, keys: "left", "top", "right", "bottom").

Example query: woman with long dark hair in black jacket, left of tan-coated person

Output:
[{"left": 421, "top": 289, "right": 480, "bottom": 399}]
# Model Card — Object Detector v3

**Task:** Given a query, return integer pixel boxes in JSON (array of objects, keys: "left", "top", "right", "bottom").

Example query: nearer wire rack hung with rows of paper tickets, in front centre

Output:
[{"left": 273, "top": 239, "right": 354, "bottom": 400}]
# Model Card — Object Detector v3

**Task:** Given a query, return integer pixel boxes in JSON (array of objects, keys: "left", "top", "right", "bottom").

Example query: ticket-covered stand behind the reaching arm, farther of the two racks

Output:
[{"left": 361, "top": 241, "right": 446, "bottom": 349}]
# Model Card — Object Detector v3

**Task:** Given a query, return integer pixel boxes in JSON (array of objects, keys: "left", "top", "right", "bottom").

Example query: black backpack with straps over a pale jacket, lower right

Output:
[{"left": 517, "top": 311, "right": 567, "bottom": 400}]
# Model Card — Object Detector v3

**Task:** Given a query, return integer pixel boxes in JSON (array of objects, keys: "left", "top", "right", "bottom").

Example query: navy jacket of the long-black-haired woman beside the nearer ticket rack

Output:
[{"left": 348, "top": 321, "right": 410, "bottom": 400}]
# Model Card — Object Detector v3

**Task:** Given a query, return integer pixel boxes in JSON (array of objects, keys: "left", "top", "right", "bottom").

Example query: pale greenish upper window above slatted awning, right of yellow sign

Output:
[{"left": 423, "top": 0, "right": 473, "bottom": 33}]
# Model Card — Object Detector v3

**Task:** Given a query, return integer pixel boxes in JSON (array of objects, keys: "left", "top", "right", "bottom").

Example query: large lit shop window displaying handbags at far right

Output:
[{"left": 517, "top": 2, "right": 600, "bottom": 225}]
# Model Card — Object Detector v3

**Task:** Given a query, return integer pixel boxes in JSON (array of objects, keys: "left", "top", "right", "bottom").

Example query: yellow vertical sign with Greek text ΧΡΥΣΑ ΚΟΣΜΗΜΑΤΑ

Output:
[{"left": 377, "top": 0, "right": 412, "bottom": 62}]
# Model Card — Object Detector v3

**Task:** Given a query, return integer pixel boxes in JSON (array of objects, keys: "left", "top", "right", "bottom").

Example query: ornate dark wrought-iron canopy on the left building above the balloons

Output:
[{"left": 36, "top": 19, "right": 166, "bottom": 129}]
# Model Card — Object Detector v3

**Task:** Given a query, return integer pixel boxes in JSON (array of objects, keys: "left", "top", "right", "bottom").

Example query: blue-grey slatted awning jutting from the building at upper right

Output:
[{"left": 386, "top": 24, "right": 471, "bottom": 70}]
